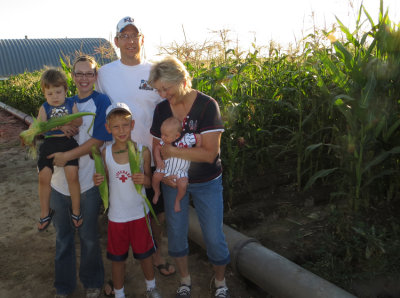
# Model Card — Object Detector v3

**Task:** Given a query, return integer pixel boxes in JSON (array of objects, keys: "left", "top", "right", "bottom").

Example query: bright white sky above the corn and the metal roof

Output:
[{"left": 0, "top": 0, "right": 400, "bottom": 60}]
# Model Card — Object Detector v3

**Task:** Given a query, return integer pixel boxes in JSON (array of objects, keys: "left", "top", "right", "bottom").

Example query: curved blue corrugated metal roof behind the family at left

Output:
[{"left": 0, "top": 38, "right": 117, "bottom": 77}]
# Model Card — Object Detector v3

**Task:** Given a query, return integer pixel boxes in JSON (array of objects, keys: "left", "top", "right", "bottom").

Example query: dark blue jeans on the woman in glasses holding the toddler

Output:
[{"left": 50, "top": 187, "right": 104, "bottom": 295}]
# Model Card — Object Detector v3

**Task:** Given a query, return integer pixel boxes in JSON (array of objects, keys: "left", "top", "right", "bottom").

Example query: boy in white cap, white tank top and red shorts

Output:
[{"left": 93, "top": 102, "right": 161, "bottom": 298}]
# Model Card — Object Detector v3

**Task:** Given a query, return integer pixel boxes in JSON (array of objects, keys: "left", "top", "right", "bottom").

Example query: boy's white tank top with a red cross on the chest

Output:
[{"left": 105, "top": 144, "right": 149, "bottom": 222}]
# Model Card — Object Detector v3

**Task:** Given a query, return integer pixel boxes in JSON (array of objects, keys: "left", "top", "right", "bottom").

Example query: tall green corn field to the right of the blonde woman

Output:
[{"left": 187, "top": 1, "right": 400, "bottom": 212}]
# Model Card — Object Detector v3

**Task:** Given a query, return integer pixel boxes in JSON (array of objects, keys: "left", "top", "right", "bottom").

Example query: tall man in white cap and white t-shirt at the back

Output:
[{"left": 96, "top": 17, "right": 175, "bottom": 276}]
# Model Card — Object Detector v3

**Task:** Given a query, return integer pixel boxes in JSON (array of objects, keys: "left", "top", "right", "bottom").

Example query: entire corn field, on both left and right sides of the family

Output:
[{"left": 0, "top": 1, "right": 400, "bottom": 288}]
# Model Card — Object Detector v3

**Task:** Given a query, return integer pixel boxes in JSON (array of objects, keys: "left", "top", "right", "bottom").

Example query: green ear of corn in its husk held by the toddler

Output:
[{"left": 19, "top": 112, "right": 96, "bottom": 158}]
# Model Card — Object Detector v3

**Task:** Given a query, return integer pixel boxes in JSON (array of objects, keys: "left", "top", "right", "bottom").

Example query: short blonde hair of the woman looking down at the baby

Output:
[{"left": 148, "top": 56, "right": 192, "bottom": 89}]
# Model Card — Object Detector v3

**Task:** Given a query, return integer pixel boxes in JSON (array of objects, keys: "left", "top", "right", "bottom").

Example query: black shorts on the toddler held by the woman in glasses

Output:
[{"left": 37, "top": 137, "right": 79, "bottom": 172}]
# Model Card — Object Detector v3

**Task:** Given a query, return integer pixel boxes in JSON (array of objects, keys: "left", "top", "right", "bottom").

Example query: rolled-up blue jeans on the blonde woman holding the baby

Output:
[{"left": 162, "top": 176, "right": 230, "bottom": 265}]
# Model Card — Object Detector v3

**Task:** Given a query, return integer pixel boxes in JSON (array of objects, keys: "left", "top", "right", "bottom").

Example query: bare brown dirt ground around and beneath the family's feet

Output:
[{"left": 0, "top": 109, "right": 267, "bottom": 298}]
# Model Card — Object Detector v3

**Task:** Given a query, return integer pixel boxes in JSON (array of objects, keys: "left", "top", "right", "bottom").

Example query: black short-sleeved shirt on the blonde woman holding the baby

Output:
[{"left": 150, "top": 91, "right": 224, "bottom": 183}]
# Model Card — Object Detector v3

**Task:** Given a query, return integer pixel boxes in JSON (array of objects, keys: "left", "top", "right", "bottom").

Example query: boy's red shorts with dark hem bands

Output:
[{"left": 107, "top": 216, "right": 156, "bottom": 262}]
